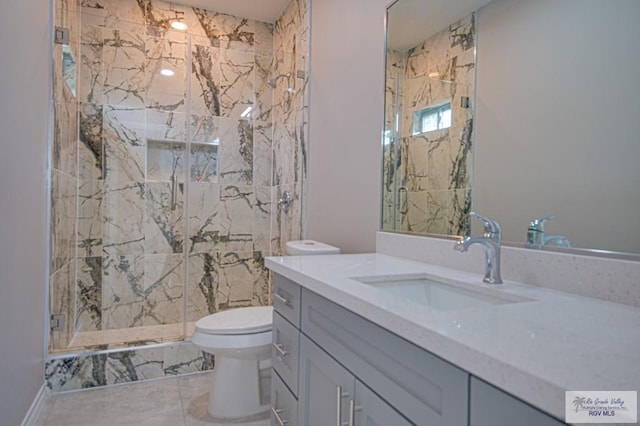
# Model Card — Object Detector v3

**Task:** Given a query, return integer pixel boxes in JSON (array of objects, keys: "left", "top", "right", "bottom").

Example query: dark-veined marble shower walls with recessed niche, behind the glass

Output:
[{"left": 51, "top": 0, "right": 309, "bottom": 350}]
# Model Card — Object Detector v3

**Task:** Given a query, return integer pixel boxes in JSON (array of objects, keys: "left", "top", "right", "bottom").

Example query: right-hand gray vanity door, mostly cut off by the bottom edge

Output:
[{"left": 350, "top": 380, "right": 413, "bottom": 426}]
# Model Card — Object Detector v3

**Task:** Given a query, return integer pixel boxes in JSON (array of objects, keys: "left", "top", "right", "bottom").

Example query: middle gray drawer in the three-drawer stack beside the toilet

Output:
[{"left": 271, "top": 312, "right": 300, "bottom": 395}]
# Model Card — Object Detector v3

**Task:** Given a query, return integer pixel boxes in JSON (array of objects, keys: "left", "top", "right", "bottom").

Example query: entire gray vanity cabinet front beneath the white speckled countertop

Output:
[{"left": 271, "top": 274, "right": 563, "bottom": 426}]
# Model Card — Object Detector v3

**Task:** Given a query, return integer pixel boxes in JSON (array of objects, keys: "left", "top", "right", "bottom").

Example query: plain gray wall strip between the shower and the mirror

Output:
[{"left": 307, "top": 0, "right": 390, "bottom": 253}]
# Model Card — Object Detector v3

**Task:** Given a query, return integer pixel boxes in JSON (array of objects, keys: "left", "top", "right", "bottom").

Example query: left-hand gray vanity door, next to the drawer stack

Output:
[{"left": 298, "top": 334, "right": 355, "bottom": 426}]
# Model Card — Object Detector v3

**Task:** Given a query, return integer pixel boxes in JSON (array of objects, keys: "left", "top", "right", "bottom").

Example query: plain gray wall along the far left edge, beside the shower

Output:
[{"left": 0, "top": 0, "right": 50, "bottom": 425}]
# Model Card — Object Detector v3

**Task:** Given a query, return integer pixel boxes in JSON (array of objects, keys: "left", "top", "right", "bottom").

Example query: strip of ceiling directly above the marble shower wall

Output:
[{"left": 173, "top": 0, "right": 291, "bottom": 22}]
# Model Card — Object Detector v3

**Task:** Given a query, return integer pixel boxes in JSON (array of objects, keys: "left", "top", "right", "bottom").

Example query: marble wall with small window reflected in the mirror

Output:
[{"left": 383, "top": 15, "right": 476, "bottom": 235}]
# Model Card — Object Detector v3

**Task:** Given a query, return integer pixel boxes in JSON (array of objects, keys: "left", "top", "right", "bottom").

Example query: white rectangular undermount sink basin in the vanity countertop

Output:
[{"left": 351, "top": 274, "right": 529, "bottom": 311}]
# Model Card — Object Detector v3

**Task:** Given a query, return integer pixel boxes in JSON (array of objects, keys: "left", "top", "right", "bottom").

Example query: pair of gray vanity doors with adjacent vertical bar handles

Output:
[{"left": 299, "top": 335, "right": 412, "bottom": 426}]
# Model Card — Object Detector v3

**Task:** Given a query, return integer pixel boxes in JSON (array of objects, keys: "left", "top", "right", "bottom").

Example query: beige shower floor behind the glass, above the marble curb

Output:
[{"left": 55, "top": 322, "right": 195, "bottom": 353}]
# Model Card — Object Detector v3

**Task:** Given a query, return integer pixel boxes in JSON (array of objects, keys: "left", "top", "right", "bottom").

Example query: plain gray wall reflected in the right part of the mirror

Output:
[{"left": 474, "top": 0, "right": 640, "bottom": 252}]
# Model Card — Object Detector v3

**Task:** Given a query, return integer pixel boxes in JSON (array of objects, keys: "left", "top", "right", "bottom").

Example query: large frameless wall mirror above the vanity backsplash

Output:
[{"left": 382, "top": 0, "right": 640, "bottom": 254}]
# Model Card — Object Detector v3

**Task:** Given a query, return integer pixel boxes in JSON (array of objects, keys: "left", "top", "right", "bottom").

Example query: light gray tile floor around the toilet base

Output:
[{"left": 34, "top": 372, "right": 269, "bottom": 426}]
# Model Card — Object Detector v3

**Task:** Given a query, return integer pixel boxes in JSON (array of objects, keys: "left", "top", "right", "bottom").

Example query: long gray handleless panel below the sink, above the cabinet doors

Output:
[{"left": 301, "top": 289, "right": 469, "bottom": 426}]
